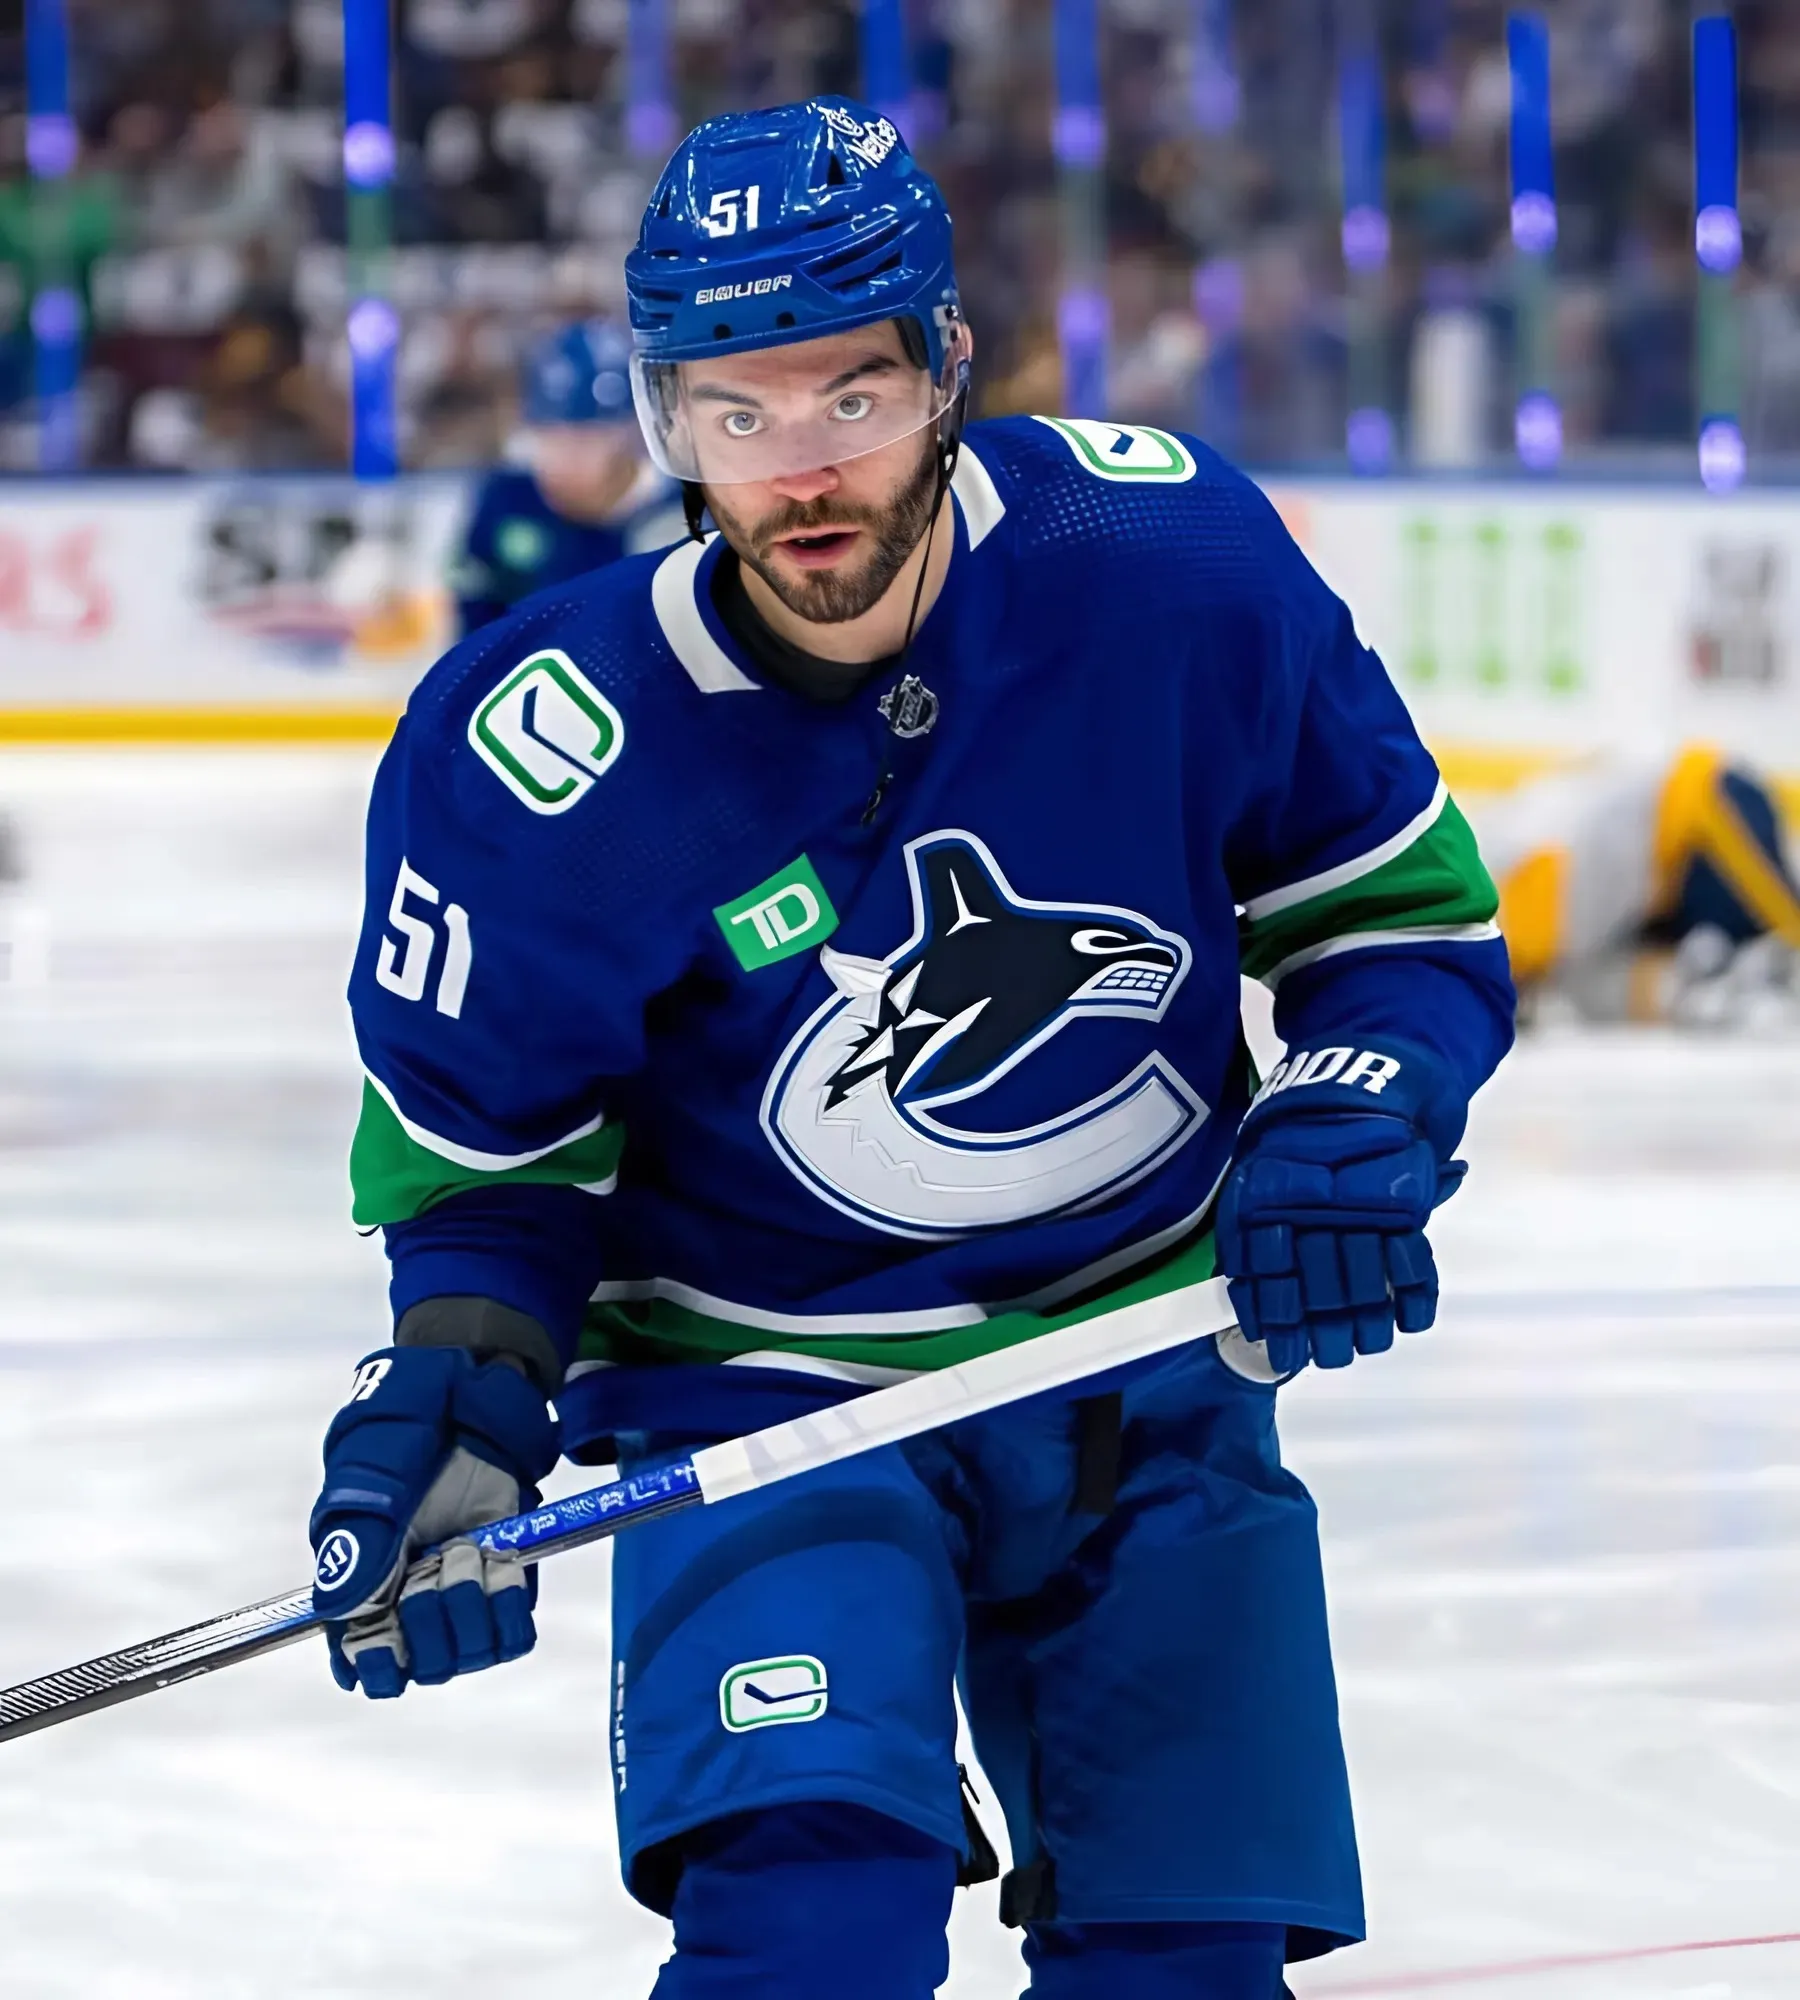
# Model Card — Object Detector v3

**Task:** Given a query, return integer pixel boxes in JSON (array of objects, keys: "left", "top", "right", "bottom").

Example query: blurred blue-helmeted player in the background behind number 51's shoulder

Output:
[{"left": 452, "top": 320, "right": 682, "bottom": 638}]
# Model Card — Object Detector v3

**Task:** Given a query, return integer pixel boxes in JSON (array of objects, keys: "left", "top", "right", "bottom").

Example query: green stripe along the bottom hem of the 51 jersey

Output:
[{"left": 578, "top": 1230, "right": 1218, "bottom": 1370}]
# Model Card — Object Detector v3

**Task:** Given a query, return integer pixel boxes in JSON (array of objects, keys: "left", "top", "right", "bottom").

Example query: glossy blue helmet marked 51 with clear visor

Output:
[{"left": 626, "top": 96, "right": 968, "bottom": 484}]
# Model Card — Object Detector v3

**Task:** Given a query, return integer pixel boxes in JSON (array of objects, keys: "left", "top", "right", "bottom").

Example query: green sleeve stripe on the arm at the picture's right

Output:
[{"left": 1240, "top": 798, "right": 1500, "bottom": 980}]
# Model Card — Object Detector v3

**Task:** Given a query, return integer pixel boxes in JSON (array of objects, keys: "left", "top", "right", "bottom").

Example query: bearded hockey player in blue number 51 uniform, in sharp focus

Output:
[{"left": 312, "top": 98, "right": 1512, "bottom": 2000}]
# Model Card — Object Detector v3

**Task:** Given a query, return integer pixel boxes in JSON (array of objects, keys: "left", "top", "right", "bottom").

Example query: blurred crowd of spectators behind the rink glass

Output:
[{"left": 0, "top": 0, "right": 1800, "bottom": 470}]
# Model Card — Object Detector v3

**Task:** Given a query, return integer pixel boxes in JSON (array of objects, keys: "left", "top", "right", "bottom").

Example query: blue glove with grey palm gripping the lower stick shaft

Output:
[{"left": 308, "top": 1348, "right": 558, "bottom": 1700}]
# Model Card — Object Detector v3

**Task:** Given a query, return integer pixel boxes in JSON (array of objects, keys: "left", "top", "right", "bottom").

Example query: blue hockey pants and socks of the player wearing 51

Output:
[{"left": 612, "top": 1340, "right": 1362, "bottom": 2000}]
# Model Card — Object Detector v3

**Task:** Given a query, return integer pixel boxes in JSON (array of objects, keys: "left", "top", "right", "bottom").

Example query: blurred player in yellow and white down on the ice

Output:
[{"left": 1470, "top": 744, "right": 1800, "bottom": 1028}]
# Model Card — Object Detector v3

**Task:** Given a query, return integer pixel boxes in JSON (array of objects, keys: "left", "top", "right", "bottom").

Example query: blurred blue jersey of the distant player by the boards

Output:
[{"left": 450, "top": 466, "right": 688, "bottom": 638}]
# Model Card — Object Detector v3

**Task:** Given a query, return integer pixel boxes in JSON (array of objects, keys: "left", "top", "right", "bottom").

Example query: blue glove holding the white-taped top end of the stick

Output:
[{"left": 1216, "top": 1044, "right": 1466, "bottom": 1376}]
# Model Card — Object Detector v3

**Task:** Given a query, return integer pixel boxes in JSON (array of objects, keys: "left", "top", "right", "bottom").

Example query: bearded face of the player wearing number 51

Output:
[{"left": 686, "top": 322, "right": 938, "bottom": 624}]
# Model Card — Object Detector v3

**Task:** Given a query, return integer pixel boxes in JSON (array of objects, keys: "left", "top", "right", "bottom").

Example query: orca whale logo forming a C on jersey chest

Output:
[{"left": 762, "top": 830, "right": 1208, "bottom": 1240}]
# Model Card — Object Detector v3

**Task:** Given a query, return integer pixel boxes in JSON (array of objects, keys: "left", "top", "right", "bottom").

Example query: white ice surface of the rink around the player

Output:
[{"left": 0, "top": 752, "right": 1800, "bottom": 2000}]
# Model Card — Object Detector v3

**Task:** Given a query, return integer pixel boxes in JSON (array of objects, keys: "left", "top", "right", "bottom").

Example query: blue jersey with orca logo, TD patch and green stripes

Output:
[{"left": 350, "top": 418, "right": 1512, "bottom": 1446}]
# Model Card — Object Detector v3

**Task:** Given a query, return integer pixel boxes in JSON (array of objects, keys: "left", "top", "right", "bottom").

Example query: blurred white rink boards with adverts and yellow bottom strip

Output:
[{"left": 0, "top": 476, "right": 1800, "bottom": 788}]
